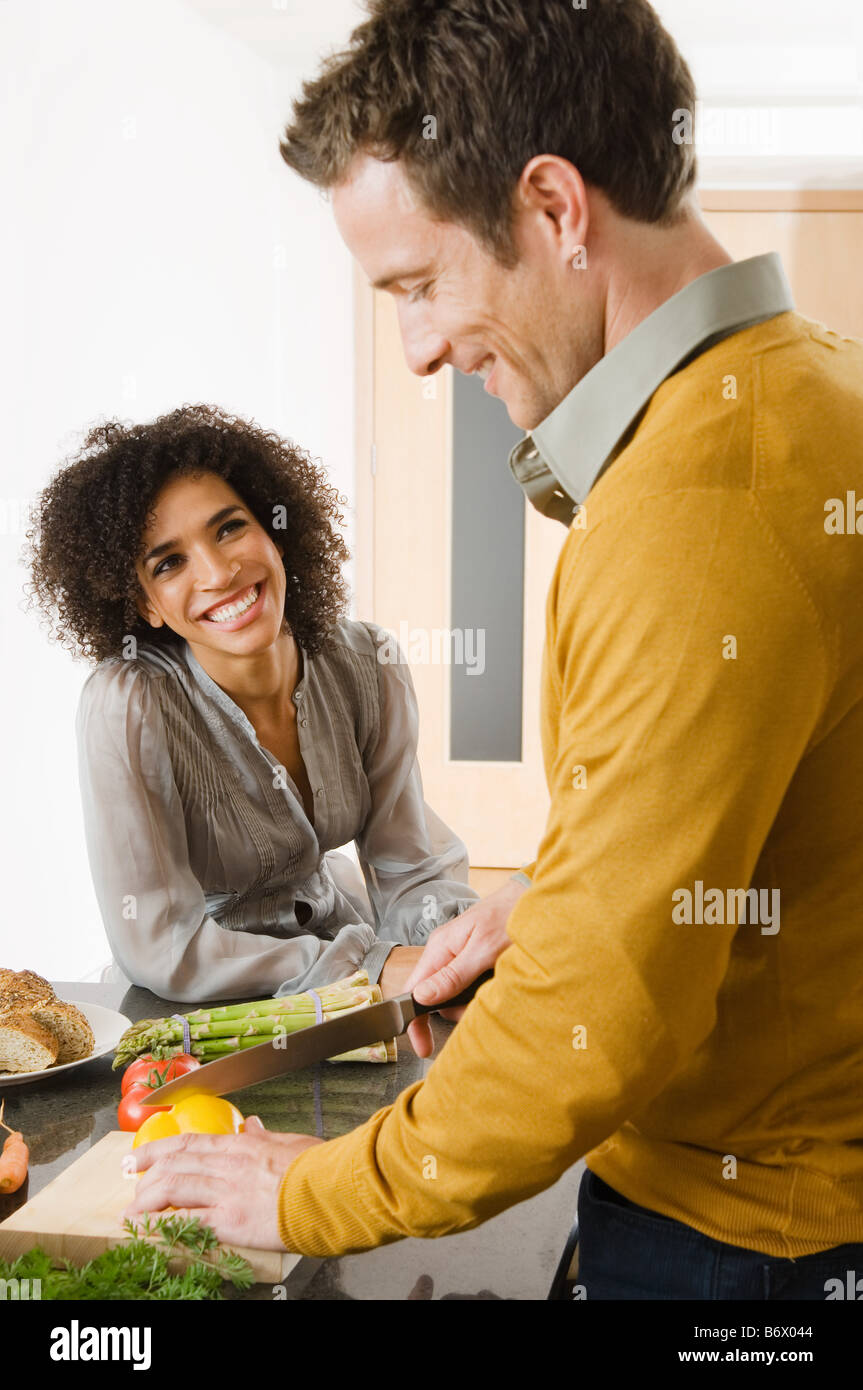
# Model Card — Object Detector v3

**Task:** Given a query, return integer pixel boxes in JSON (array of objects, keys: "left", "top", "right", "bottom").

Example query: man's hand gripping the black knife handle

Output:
[{"left": 403, "top": 878, "right": 527, "bottom": 1056}]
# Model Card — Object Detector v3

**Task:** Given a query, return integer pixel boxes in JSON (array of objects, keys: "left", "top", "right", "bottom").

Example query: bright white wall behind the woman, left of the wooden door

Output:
[{"left": 0, "top": 0, "right": 353, "bottom": 980}]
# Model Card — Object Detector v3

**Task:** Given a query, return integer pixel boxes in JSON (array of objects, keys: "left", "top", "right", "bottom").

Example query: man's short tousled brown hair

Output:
[{"left": 279, "top": 0, "right": 696, "bottom": 265}]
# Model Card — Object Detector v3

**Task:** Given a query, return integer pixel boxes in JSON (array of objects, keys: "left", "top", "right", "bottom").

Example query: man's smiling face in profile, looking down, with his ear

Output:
[{"left": 332, "top": 156, "right": 602, "bottom": 430}]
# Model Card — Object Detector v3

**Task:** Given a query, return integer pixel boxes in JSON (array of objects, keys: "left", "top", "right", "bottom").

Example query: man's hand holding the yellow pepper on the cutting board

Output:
[{"left": 122, "top": 1115, "right": 324, "bottom": 1250}]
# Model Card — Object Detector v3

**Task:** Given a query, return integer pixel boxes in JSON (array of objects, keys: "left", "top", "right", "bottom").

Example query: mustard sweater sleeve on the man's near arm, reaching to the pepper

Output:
[{"left": 272, "top": 488, "right": 830, "bottom": 1255}]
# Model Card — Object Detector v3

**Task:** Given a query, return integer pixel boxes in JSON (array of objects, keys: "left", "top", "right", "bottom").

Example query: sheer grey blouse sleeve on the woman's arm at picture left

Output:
[{"left": 75, "top": 660, "right": 375, "bottom": 1002}]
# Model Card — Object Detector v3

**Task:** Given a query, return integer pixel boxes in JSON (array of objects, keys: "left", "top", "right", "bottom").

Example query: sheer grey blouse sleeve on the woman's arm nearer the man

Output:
[{"left": 356, "top": 624, "right": 479, "bottom": 945}]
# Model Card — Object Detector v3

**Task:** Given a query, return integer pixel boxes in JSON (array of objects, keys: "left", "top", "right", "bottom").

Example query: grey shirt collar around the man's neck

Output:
[{"left": 509, "top": 252, "right": 795, "bottom": 527}]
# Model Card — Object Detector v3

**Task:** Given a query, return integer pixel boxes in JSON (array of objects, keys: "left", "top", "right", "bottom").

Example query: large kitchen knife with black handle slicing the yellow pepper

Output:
[{"left": 140, "top": 970, "right": 493, "bottom": 1105}]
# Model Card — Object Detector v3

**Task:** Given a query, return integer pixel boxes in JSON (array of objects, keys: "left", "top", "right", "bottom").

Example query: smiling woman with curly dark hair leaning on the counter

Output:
[{"left": 29, "top": 406, "right": 477, "bottom": 1002}]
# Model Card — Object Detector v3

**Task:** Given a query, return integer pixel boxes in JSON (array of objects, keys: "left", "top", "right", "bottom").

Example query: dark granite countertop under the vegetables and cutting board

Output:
[{"left": 0, "top": 980, "right": 584, "bottom": 1300}]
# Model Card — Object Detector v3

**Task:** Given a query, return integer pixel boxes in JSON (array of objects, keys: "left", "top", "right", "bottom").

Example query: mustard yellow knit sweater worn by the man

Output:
[{"left": 279, "top": 313, "right": 863, "bottom": 1257}]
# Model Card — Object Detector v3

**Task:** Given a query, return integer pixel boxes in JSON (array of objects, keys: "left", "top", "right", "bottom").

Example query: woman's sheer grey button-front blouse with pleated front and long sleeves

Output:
[{"left": 75, "top": 619, "right": 478, "bottom": 1004}]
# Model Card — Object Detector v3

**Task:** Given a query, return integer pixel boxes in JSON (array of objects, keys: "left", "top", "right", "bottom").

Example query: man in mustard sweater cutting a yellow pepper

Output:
[{"left": 126, "top": 0, "right": 863, "bottom": 1298}]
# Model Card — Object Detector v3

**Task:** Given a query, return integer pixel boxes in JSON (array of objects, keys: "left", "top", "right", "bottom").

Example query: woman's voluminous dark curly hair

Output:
[{"left": 26, "top": 404, "right": 349, "bottom": 662}]
